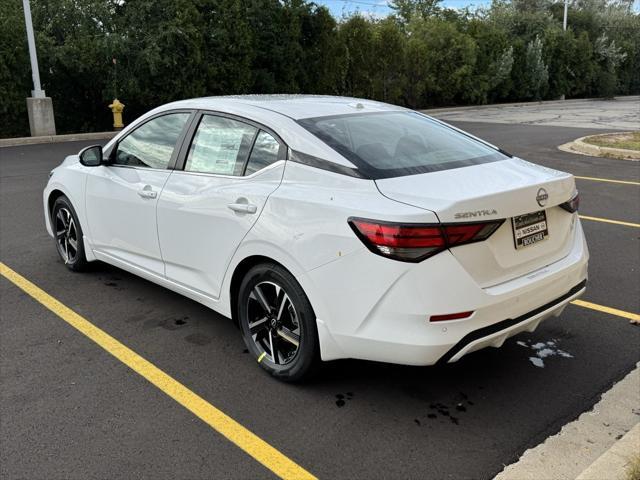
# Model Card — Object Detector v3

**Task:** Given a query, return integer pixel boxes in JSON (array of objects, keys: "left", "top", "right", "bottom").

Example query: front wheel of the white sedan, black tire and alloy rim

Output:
[{"left": 51, "top": 195, "right": 89, "bottom": 272}]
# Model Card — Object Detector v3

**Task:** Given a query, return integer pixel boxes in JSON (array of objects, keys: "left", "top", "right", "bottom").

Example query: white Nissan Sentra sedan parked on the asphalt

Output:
[{"left": 44, "top": 96, "right": 588, "bottom": 381}]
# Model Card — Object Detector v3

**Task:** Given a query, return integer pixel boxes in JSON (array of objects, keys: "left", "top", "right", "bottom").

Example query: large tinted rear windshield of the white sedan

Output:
[{"left": 298, "top": 112, "right": 507, "bottom": 178}]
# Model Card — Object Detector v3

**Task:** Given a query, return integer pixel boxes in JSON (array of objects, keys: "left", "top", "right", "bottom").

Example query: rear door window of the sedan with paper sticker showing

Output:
[{"left": 184, "top": 115, "right": 258, "bottom": 176}]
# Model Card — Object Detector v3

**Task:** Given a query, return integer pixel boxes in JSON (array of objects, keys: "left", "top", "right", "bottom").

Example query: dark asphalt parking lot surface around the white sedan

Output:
[{"left": 0, "top": 114, "right": 640, "bottom": 479}]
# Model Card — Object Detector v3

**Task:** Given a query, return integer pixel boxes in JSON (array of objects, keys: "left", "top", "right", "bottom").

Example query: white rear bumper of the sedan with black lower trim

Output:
[{"left": 308, "top": 221, "right": 589, "bottom": 365}]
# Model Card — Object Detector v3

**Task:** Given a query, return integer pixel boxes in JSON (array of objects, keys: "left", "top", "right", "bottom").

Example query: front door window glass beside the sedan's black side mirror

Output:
[{"left": 113, "top": 113, "right": 190, "bottom": 169}]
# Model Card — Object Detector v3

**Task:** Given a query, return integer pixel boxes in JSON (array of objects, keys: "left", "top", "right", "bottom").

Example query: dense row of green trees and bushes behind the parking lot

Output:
[{"left": 0, "top": 0, "right": 640, "bottom": 137}]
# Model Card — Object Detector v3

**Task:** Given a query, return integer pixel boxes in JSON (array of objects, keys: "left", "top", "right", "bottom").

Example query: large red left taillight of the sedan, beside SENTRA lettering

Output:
[{"left": 349, "top": 218, "right": 504, "bottom": 262}]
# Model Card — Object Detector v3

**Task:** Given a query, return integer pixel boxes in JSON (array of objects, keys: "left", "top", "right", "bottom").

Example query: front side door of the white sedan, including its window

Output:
[{"left": 85, "top": 111, "right": 192, "bottom": 275}]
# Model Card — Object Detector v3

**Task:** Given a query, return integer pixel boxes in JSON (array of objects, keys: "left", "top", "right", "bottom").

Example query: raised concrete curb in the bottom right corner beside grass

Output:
[{"left": 576, "top": 422, "right": 640, "bottom": 480}]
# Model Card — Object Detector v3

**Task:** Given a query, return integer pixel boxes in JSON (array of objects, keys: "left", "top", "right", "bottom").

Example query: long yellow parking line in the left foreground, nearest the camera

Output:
[{"left": 0, "top": 262, "right": 315, "bottom": 480}]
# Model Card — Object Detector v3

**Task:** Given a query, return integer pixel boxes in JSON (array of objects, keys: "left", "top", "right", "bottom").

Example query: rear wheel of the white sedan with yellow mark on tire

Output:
[{"left": 237, "top": 263, "right": 320, "bottom": 382}]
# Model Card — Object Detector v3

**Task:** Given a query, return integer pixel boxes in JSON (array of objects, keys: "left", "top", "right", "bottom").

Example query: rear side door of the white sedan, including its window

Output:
[{"left": 158, "top": 113, "right": 286, "bottom": 298}]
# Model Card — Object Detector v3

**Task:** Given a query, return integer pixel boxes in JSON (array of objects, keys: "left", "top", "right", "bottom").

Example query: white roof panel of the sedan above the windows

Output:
[{"left": 159, "top": 95, "right": 406, "bottom": 120}]
